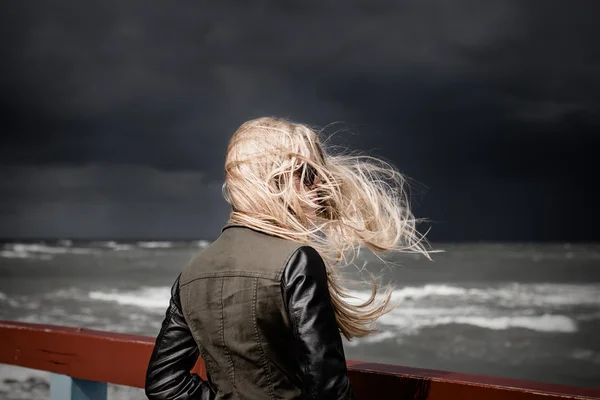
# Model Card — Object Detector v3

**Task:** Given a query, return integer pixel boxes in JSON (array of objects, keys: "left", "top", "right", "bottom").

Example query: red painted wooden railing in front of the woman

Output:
[{"left": 0, "top": 321, "right": 600, "bottom": 400}]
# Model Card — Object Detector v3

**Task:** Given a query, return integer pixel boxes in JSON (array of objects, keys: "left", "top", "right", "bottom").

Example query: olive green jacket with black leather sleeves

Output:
[{"left": 145, "top": 225, "right": 355, "bottom": 400}]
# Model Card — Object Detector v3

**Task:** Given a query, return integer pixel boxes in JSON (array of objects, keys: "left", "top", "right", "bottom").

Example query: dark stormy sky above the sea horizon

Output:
[{"left": 0, "top": 0, "right": 600, "bottom": 242}]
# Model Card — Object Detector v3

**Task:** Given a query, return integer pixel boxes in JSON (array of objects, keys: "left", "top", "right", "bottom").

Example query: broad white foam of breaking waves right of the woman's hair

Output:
[{"left": 342, "top": 284, "right": 600, "bottom": 343}]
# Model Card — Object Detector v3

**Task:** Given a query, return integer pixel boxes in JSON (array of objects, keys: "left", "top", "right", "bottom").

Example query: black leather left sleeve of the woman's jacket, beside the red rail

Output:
[{"left": 145, "top": 277, "right": 215, "bottom": 400}]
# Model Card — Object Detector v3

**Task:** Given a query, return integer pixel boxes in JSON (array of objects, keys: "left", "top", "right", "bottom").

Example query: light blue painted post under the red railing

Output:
[{"left": 50, "top": 373, "right": 106, "bottom": 400}]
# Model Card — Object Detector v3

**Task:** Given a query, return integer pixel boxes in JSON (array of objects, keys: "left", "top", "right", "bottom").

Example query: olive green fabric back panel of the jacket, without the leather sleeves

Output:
[{"left": 180, "top": 226, "right": 302, "bottom": 400}]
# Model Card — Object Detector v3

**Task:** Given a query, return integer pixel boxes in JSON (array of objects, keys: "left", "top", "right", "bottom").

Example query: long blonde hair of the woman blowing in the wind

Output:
[{"left": 224, "top": 117, "right": 429, "bottom": 339}]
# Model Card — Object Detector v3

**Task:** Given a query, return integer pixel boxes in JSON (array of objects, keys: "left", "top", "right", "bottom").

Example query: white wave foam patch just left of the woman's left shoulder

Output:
[{"left": 88, "top": 286, "right": 171, "bottom": 310}]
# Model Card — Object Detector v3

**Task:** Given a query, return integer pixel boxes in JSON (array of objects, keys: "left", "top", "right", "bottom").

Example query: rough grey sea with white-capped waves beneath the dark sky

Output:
[{"left": 0, "top": 240, "right": 600, "bottom": 399}]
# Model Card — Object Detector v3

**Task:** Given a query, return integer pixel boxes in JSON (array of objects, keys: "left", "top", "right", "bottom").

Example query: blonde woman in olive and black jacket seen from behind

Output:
[{"left": 146, "top": 118, "right": 428, "bottom": 399}]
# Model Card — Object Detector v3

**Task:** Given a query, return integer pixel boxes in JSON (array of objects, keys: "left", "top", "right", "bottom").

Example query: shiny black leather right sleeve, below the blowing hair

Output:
[{"left": 281, "top": 246, "right": 355, "bottom": 400}]
